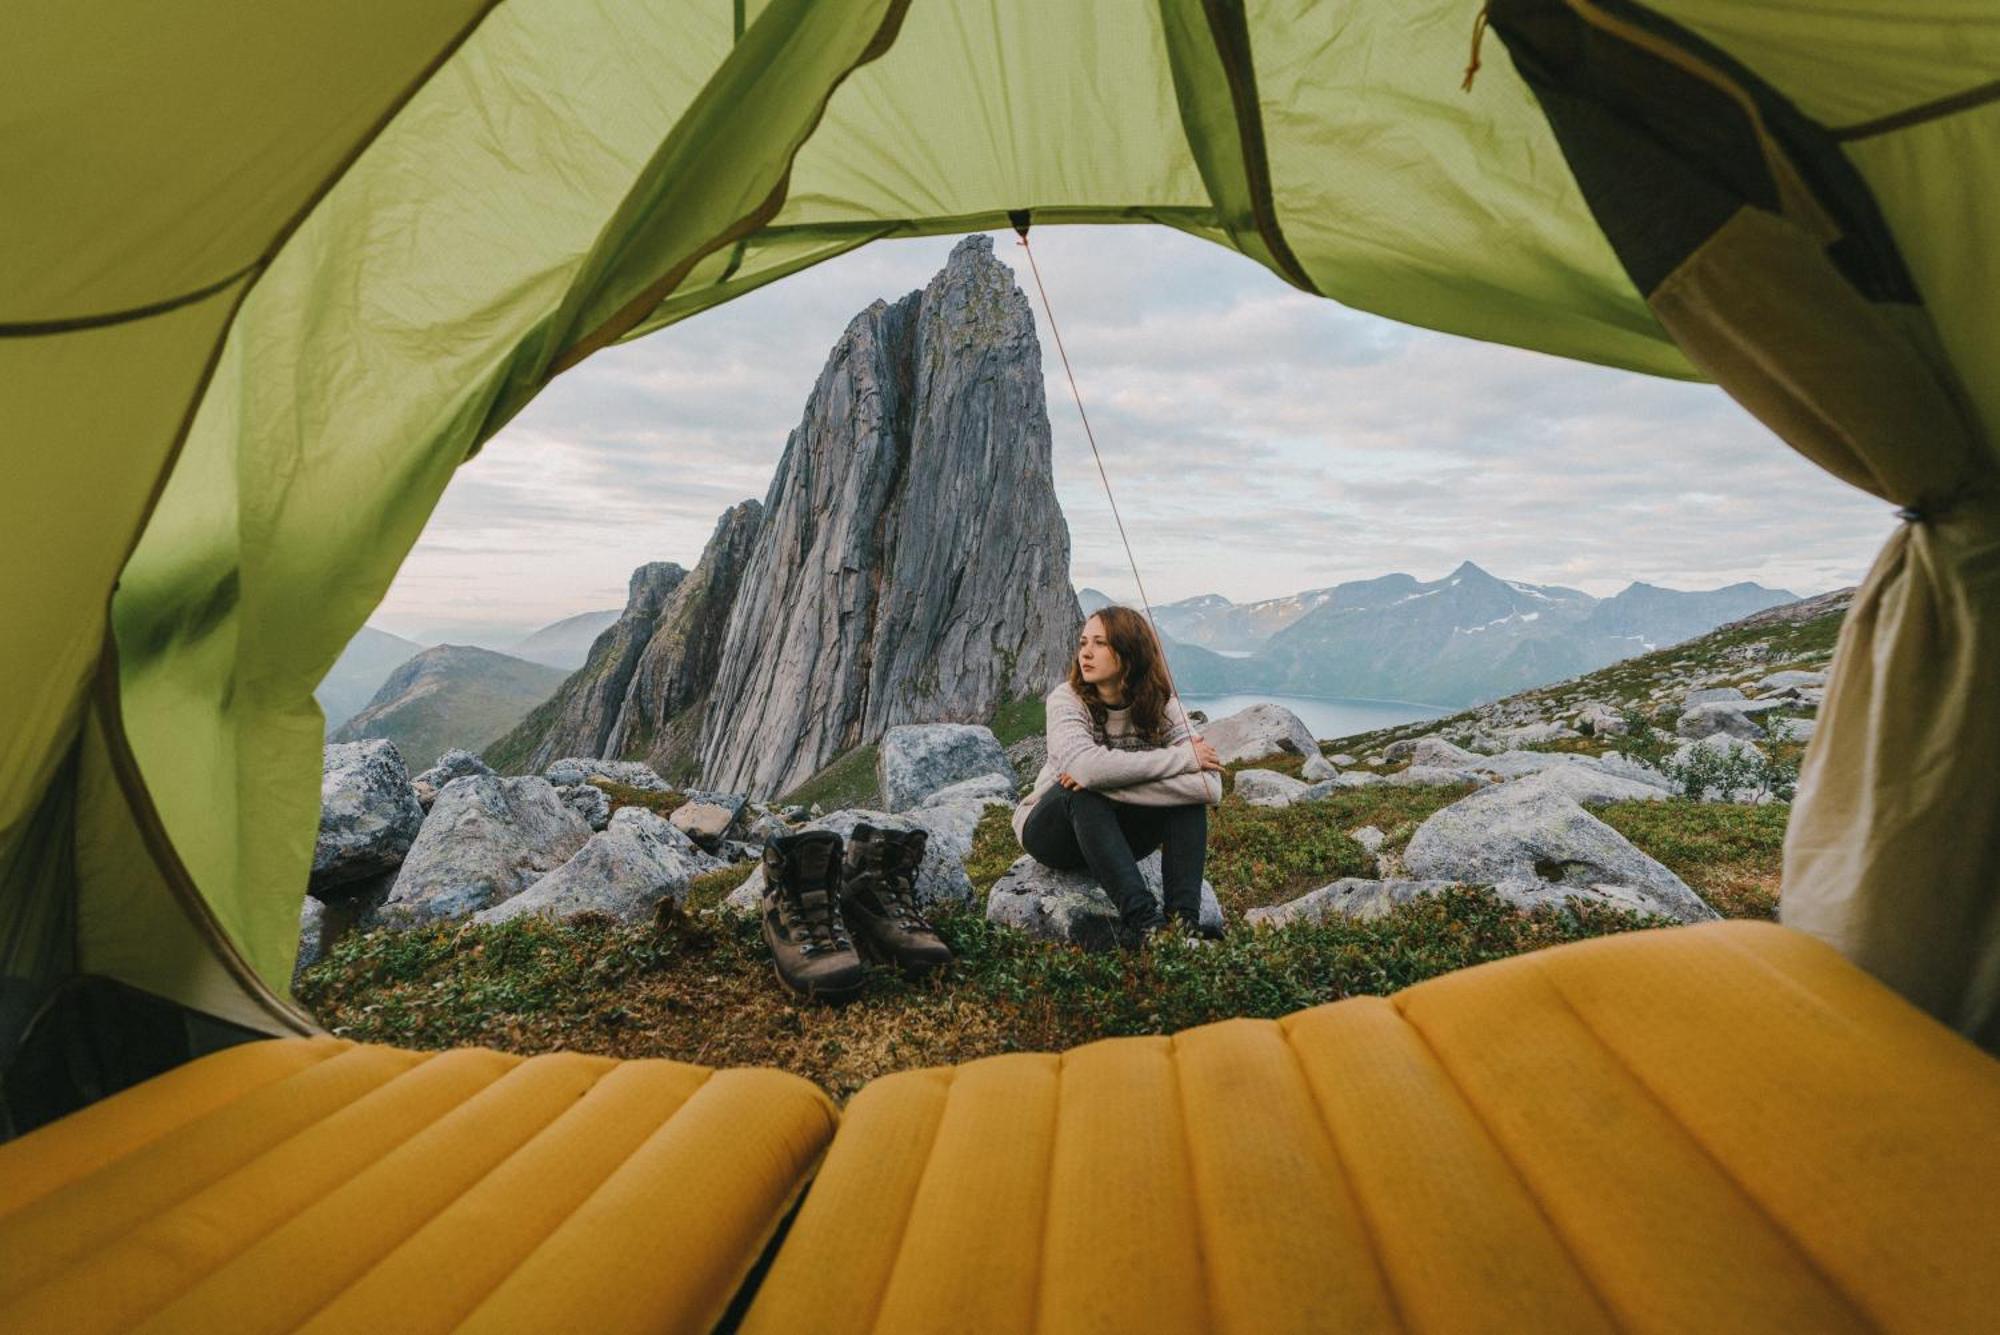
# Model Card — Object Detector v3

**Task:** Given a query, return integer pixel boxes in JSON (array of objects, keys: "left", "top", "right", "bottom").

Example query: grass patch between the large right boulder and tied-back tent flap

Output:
[{"left": 1594, "top": 797, "right": 1792, "bottom": 919}]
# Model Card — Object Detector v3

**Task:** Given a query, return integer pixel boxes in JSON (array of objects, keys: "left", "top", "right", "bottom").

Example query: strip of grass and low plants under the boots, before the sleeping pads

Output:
[{"left": 300, "top": 889, "right": 1652, "bottom": 1099}]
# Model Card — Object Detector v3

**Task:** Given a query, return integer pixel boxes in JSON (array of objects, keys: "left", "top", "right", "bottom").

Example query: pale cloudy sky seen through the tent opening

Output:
[{"left": 372, "top": 228, "right": 1894, "bottom": 642}]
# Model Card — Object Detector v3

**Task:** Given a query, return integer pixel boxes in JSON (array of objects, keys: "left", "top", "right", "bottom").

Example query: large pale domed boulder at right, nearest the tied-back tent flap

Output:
[{"left": 1402, "top": 781, "right": 1716, "bottom": 923}]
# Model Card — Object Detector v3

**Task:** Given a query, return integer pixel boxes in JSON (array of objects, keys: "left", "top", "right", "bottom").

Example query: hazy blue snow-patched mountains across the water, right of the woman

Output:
[{"left": 1080, "top": 562, "right": 1798, "bottom": 707}]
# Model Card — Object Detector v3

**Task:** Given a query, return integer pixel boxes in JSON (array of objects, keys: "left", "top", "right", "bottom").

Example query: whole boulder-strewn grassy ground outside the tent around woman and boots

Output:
[{"left": 298, "top": 598, "right": 1844, "bottom": 1091}]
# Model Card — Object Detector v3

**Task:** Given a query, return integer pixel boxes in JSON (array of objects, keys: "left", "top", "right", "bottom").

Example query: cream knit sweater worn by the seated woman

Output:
[{"left": 1014, "top": 681, "right": 1222, "bottom": 839}]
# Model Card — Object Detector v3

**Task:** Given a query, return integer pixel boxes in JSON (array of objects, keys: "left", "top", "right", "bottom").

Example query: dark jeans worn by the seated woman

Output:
[{"left": 1020, "top": 783, "right": 1208, "bottom": 927}]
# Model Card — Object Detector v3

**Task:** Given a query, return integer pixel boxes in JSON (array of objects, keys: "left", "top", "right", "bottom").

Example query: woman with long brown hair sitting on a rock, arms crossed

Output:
[{"left": 1014, "top": 608, "right": 1222, "bottom": 937}]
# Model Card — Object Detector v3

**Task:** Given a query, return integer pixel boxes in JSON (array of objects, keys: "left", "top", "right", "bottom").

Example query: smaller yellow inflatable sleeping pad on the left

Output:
[{"left": 0, "top": 1039, "right": 836, "bottom": 1335}]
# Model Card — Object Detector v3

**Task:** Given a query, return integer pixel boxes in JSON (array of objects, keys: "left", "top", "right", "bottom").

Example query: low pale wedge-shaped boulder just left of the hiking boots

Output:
[{"left": 472, "top": 807, "right": 724, "bottom": 923}]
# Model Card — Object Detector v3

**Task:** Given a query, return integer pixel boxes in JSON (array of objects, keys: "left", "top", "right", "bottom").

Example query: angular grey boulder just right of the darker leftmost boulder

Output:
[{"left": 382, "top": 777, "right": 590, "bottom": 927}]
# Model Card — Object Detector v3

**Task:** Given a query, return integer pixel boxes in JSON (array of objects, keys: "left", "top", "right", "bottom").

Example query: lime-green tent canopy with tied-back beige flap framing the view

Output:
[{"left": 0, "top": 0, "right": 2000, "bottom": 1059}]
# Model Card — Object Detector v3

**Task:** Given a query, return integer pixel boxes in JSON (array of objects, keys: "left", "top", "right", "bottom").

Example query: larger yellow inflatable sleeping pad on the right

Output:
[{"left": 746, "top": 923, "right": 2000, "bottom": 1335}]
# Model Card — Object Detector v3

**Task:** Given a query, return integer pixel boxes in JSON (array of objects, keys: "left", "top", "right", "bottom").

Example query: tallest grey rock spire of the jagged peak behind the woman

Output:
[{"left": 700, "top": 236, "right": 1078, "bottom": 793}]
